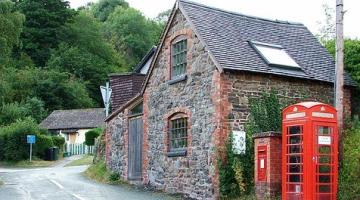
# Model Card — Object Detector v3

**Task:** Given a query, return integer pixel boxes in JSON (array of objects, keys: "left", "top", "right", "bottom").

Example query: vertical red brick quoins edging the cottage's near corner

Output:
[{"left": 211, "top": 70, "right": 232, "bottom": 199}]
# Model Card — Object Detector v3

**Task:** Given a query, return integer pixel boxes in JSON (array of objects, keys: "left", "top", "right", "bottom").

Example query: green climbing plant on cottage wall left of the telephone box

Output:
[{"left": 218, "top": 91, "right": 291, "bottom": 199}]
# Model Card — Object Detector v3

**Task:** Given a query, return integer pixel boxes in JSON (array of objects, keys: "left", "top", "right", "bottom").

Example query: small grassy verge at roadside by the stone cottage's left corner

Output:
[{"left": 85, "top": 161, "right": 126, "bottom": 185}]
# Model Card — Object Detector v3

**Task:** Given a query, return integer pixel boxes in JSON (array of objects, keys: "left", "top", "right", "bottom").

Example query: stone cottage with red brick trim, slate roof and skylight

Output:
[{"left": 106, "top": 0, "right": 354, "bottom": 199}]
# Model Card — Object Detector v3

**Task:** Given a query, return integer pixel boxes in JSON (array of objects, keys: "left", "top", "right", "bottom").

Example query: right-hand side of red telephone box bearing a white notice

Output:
[{"left": 312, "top": 122, "right": 338, "bottom": 200}]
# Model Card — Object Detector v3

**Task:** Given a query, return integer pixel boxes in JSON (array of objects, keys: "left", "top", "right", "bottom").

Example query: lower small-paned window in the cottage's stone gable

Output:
[{"left": 169, "top": 118, "right": 187, "bottom": 150}]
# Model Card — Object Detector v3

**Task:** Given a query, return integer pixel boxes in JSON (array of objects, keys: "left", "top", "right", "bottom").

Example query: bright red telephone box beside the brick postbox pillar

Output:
[{"left": 282, "top": 102, "right": 338, "bottom": 200}]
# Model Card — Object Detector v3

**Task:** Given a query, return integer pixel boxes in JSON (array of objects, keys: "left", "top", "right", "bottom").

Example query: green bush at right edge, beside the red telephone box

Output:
[{"left": 339, "top": 127, "right": 360, "bottom": 200}]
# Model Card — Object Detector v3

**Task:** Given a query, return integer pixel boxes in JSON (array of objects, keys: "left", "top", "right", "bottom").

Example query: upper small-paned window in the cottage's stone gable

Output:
[{"left": 171, "top": 40, "right": 187, "bottom": 78}]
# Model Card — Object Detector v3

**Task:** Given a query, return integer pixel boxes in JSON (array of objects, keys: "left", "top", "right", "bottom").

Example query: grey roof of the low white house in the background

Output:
[{"left": 40, "top": 108, "right": 105, "bottom": 130}]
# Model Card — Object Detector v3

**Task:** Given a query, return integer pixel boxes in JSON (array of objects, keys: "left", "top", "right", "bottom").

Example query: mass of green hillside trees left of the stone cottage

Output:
[{"left": 0, "top": 0, "right": 166, "bottom": 126}]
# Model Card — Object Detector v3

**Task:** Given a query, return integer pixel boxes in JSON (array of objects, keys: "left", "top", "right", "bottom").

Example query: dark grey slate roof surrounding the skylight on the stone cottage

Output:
[{"left": 178, "top": 0, "right": 356, "bottom": 85}]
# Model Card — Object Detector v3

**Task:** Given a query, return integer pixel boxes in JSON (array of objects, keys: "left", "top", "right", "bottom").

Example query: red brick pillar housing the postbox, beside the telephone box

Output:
[{"left": 254, "top": 136, "right": 282, "bottom": 200}]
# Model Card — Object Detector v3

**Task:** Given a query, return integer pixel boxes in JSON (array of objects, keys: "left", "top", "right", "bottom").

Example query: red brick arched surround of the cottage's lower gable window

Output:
[{"left": 163, "top": 108, "right": 192, "bottom": 157}]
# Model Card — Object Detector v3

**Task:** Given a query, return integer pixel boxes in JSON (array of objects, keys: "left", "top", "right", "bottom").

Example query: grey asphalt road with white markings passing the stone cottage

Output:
[{"left": 0, "top": 159, "right": 174, "bottom": 200}]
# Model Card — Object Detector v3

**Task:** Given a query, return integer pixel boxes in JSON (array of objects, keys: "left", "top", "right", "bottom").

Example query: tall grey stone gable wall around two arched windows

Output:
[{"left": 143, "top": 9, "right": 216, "bottom": 199}]
